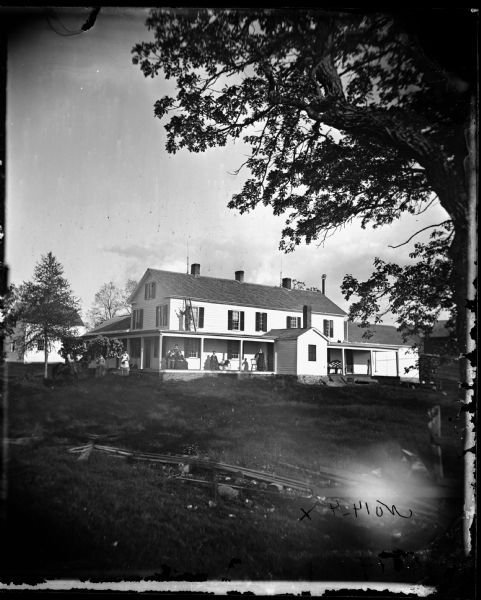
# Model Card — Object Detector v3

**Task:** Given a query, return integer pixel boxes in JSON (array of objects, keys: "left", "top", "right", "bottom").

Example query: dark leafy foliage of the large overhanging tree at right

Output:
[{"left": 132, "top": 9, "right": 476, "bottom": 350}]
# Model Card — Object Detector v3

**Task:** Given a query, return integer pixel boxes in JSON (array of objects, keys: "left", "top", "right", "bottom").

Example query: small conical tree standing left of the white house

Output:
[{"left": 16, "top": 252, "right": 80, "bottom": 378}]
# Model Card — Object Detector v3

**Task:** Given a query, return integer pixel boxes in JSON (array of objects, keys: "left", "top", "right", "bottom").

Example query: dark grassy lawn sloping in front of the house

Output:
[{"left": 1, "top": 373, "right": 462, "bottom": 582}]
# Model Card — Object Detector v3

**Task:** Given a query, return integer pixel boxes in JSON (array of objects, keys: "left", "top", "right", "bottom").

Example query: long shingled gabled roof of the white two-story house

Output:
[{"left": 131, "top": 269, "right": 346, "bottom": 316}]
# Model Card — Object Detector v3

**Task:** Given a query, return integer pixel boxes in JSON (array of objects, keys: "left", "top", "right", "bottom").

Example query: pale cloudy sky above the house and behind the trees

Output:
[{"left": 6, "top": 8, "right": 446, "bottom": 322}]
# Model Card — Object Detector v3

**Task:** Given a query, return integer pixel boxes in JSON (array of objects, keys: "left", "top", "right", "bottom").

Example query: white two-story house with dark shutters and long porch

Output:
[{"left": 86, "top": 264, "right": 416, "bottom": 378}]
